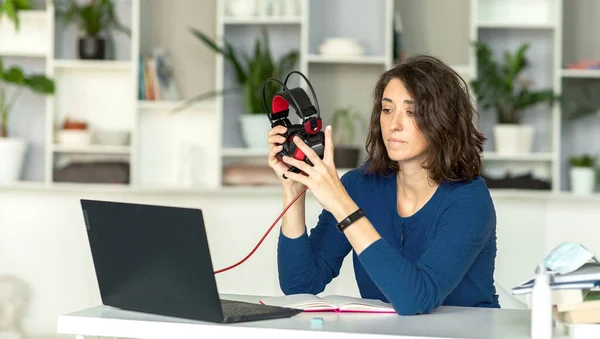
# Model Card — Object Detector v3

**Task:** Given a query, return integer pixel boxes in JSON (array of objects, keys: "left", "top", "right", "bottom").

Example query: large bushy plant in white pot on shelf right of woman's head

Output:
[{"left": 471, "top": 42, "right": 556, "bottom": 154}]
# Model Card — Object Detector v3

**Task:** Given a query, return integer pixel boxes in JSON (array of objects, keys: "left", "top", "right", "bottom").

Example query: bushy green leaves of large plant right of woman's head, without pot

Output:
[{"left": 471, "top": 42, "right": 557, "bottom": 124}]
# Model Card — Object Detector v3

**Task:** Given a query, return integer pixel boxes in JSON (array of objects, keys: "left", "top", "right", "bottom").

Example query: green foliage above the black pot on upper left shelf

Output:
[{"left": 54, "top": 0, "right": 131, "bottom": 37}]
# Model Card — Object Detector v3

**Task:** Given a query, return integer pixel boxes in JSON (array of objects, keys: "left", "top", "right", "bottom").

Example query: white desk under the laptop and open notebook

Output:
[{"left": 58, "top": 295, "right": 566, "bottom": 339}]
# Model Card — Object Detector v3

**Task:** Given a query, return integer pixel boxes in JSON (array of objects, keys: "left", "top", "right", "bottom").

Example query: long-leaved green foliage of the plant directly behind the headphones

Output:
[{"left": 185, "top": 28, "right": 300, "bottom": 114}]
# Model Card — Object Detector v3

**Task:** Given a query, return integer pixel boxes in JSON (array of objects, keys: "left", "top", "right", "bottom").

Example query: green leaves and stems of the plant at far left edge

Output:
[{"left": 0, "top": 59, "right": 54, "bottom": 137}]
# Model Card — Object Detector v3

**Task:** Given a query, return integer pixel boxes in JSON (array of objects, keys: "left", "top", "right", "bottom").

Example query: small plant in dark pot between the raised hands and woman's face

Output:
[{"left": 331, "top": 107, "right": 365, "bottom": 168}]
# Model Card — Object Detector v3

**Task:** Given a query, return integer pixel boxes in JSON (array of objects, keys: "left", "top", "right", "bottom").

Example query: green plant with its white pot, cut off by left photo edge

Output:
[{"left": 0, "top": 59, "right": 54, "bottom": 184}]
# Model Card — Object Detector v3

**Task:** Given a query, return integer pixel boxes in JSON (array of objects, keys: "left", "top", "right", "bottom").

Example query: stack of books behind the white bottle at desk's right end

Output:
[{"left": 512, "top": 262, "right": 600, "bottom": 339}]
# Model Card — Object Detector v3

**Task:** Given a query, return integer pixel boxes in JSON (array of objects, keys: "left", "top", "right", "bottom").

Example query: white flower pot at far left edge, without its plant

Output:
[{"left": 0, "top": 138, "right": 27, "bottom": 184}]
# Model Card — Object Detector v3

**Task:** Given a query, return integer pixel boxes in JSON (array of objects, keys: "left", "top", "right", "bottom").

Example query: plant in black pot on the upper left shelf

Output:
[{"left": 55, "top": 0, "right": 131, "bottom": 60}]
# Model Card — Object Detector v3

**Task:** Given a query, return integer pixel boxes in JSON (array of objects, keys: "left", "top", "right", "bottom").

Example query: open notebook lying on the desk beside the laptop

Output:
[{"left": 260, "top": 294, "right": 396, "bottom": 313}]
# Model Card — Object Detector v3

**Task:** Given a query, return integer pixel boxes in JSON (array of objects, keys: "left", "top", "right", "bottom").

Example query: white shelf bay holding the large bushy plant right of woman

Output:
[{"left": 469, "top": 0, "right": 562, "bottom": 190}]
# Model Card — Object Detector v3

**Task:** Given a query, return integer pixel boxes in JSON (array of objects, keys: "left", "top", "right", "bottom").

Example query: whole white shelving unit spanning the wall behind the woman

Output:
[{"left": 0, "top": 0, "right": 600, "bottom": 191}]
